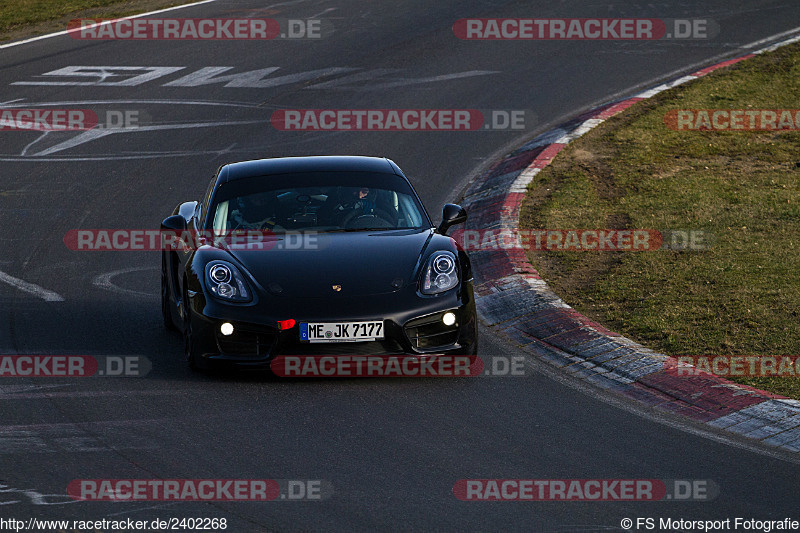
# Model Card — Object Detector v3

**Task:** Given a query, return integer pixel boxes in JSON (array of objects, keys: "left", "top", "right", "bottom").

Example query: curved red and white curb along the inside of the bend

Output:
[{"left": 463, "top": 36, "right": 800, "bottom": 452}]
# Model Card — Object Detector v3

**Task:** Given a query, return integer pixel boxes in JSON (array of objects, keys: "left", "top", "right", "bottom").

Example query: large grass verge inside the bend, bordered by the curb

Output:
[{"left": 520, "top": 45, "right": 800, "bottom": 399}]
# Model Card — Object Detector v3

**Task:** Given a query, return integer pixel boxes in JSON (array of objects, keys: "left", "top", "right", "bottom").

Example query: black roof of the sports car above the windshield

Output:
[{"left": 220, "top": 155, "right": 405, "bottom": 183}]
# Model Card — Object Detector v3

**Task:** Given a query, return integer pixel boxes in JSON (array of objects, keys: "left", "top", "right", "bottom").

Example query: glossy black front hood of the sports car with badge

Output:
[{"left": 222, "top": 229, "right": 433, "bottom": 298}]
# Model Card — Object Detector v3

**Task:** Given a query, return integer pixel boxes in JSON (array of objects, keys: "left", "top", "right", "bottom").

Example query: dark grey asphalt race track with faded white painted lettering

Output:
[{"left": 0, "top": 0, "right": 800, "bottom": 532}]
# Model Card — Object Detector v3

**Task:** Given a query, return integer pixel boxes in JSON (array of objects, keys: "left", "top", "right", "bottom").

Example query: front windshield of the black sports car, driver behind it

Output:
[{"left": 209, "top": 172, "right": 430, "bottom": 235}]
